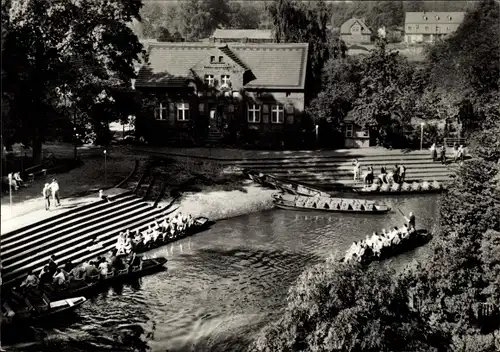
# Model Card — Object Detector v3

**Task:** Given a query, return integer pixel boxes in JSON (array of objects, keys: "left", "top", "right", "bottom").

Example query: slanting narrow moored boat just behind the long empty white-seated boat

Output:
[{"left": 245, "top": 170, "right": 332, "bottom": 197}]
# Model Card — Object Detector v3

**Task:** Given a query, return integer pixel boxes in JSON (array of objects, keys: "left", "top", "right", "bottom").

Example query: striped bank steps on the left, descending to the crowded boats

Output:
[{"left": 1, "top": 190, "right": 168, "bottom": 284}]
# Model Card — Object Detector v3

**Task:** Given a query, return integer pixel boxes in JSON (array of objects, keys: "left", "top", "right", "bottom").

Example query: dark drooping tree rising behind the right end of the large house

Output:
[{"left": 268, "top": 0, "right": 330, "bottom": 98}]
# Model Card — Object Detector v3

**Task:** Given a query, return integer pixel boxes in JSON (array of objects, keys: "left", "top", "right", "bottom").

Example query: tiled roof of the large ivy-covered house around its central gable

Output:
[{"left": 136, "top": 43, "right": 309, "bottom": 89}]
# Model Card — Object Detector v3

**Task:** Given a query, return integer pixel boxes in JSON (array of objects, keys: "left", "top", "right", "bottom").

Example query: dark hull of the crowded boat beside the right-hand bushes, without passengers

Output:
[{"left": 339, "top": 229, "right": 433, "bottom": 264}]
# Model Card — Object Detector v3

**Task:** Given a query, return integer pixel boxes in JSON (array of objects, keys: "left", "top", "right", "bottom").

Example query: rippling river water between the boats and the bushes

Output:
[{"left": 3, "top": 196, "right": 438, "bottom": 352}]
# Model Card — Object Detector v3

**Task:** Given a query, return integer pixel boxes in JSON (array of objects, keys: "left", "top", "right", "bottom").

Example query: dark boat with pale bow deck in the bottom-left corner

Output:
[{"left": 2, "top": 296, "right": 87, "bottom": 325}]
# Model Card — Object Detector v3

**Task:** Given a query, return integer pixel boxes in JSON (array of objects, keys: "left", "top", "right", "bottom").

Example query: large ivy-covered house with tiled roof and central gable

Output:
[{"left": 135, "top": 43, "right": 309, "bottom": 144}]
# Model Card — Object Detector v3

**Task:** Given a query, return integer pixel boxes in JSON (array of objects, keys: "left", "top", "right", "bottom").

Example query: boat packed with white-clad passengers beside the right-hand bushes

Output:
[{"left": 341, "top": 224, "right": 432, "bottom": 264}]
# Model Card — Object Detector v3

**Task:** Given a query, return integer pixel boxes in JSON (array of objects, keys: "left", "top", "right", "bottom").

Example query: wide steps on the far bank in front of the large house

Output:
[{"left": 222, "top": 153, "right": 456, "bottom": 189}]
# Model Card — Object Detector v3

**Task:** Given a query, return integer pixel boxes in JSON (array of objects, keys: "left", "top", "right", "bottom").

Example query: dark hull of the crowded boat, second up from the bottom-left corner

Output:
[{"left": 39, "top": 257, "right": 167, "bottom": 299}]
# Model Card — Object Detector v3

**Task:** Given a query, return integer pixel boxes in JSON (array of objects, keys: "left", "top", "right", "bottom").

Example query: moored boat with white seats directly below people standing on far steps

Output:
[{"left": 354, "top": 181, "right": 444, "bottom": 195}]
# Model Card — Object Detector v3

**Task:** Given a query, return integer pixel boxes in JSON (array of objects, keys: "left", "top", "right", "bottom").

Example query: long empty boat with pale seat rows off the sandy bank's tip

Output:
[{"left": 273, "top": 194, "right": 391, "bottom": 214}]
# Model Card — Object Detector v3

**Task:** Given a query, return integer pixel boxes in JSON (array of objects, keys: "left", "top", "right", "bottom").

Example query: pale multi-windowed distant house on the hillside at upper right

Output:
[{"left": 405, "top": 12, "right": 465, "bottom": 43}]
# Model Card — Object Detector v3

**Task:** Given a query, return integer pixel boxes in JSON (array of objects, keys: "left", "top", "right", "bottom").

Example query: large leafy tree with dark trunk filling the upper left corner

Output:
[{"left": 2, "top": 0, "right": 143, "bottom": 162}]
